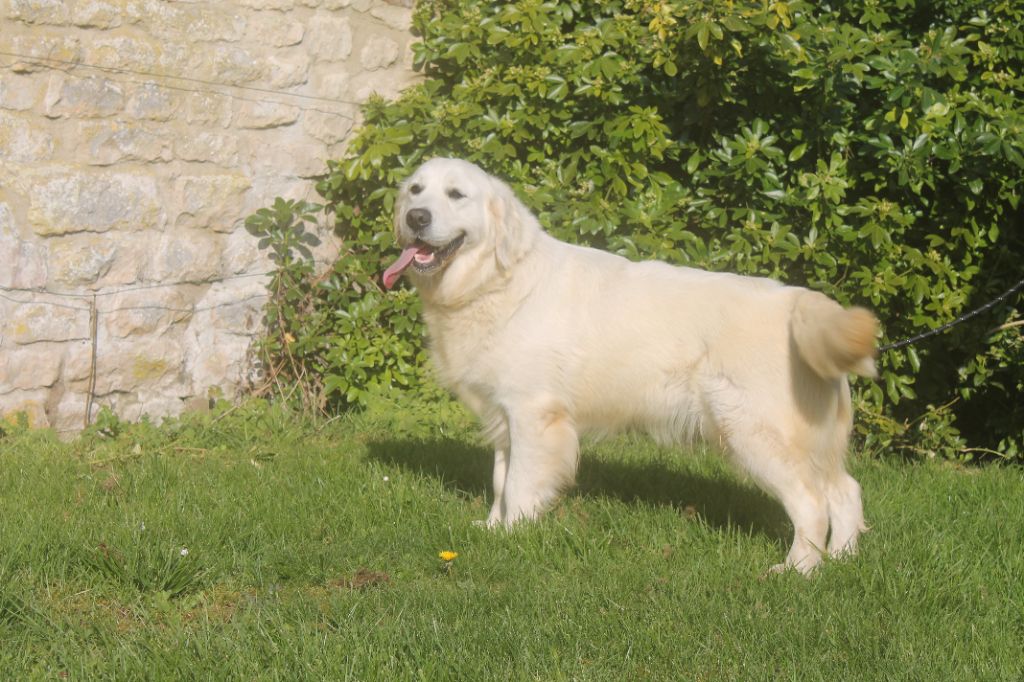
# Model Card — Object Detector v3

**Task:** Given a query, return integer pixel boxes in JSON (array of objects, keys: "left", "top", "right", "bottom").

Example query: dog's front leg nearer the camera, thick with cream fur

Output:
[{"left": 496, "top": 404, "right": 580, "bottom": 525}]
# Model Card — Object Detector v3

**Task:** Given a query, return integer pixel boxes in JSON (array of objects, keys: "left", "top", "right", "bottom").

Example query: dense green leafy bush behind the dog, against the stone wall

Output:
[{"left": 258, "top": 0, "right": 1024, "bottom": 461}]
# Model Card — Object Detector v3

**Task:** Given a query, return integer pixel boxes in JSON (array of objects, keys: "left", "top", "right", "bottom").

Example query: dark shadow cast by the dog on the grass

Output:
[{"left": 367, "top": 438, "right": 793, "bottom": 544}]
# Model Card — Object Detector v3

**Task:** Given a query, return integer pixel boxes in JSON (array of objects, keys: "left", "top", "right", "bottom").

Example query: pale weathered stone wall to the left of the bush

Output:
[{"left": 0, "top": 0, "right": 416, "bottom": 432}]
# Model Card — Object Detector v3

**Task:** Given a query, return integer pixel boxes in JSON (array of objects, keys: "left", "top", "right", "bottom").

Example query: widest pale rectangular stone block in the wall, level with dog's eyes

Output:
[{"left": 26, "top": 169, "right": 164, "bottom": 236}]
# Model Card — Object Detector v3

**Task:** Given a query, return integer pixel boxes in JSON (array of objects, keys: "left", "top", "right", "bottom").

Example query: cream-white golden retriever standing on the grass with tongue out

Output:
[{"left": 384, "top": 159, "right": 878, "bottom": 572}]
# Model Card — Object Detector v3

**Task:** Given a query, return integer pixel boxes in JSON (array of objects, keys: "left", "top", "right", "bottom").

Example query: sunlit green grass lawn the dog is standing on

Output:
[{"left": 0, "top": 399, "right": 1024, "bottom": 681}]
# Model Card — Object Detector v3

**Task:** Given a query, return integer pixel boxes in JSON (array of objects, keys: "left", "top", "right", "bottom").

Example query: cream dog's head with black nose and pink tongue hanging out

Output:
[{"left": 384, "top": 159, "right": 540, "bottom": 298}]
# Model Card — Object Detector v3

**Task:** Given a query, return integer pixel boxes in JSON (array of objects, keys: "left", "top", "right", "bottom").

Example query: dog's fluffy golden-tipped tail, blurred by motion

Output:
[{"left": 790, "top": 291, "right": 879, "bottom": 379}]
